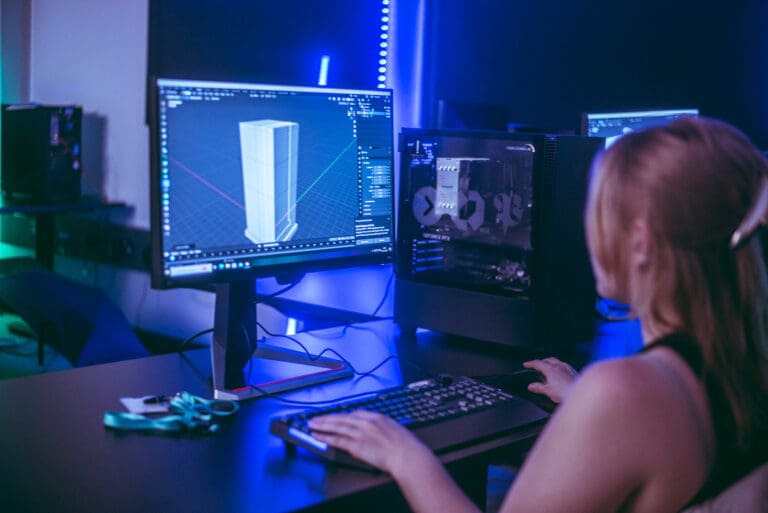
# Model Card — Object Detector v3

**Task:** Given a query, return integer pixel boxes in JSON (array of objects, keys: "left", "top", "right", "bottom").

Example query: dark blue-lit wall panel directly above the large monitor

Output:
[{"left": 147, "top": 0, "right": 382, "bottom": 88}]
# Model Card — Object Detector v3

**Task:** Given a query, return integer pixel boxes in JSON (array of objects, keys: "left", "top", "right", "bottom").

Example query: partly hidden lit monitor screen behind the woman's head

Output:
[{"left": 582, "top": 109, "right": 699, "bottom": 148}]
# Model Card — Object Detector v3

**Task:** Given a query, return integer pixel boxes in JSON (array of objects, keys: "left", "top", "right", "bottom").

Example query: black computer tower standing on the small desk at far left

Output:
[{"left": 2, "top": 104, "right": 83, "bottom": 203}]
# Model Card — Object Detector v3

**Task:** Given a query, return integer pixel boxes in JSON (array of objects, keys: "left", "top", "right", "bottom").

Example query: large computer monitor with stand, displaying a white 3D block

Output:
[{"left": 150, "top": 78, "right": 394, "bottom": 399}]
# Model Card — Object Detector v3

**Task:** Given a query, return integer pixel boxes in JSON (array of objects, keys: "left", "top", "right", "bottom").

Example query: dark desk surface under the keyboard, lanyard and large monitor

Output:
[{"left": 0, "top": 321, "right": 537, "bottom": 513}]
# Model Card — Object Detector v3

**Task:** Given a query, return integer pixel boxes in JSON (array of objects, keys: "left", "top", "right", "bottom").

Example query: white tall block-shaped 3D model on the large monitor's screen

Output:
[{"left": 240, "top": 119, "right": 299, "bottom": 244}]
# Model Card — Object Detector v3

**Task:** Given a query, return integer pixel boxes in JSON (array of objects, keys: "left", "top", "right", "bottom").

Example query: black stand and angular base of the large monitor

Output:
[{"left": 211, "top": 281, "right": 353, "bottom": 400}]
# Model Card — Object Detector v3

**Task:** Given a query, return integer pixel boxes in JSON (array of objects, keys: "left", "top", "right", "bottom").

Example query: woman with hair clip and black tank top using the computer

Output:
[{"left": 311, "top": 118, "right": 768, "bottom": 513}]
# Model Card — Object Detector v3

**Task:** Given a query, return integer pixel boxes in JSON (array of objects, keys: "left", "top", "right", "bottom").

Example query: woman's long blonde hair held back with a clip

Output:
[{"left": 585, "top": 117, "right": 768, "bottom": 447}]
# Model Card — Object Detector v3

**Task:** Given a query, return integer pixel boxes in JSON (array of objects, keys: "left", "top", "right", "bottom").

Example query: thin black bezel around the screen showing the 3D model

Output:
[{"left": 148, "top": 77, "right": 397, "bottom": 289}]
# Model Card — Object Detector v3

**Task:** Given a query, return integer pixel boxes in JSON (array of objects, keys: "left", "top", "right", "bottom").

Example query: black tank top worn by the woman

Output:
[{"left": 640, "top": 333, "right": 768, "bottom": 504}]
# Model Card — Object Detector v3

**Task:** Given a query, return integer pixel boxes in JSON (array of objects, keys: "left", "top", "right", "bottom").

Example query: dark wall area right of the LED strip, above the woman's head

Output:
[{"left": 424, "top": 0, "right": 768, "bottom": 148}]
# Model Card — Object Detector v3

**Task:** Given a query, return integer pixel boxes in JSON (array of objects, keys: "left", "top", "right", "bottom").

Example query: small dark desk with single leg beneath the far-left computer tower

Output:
[{"left": 0, "top": 196, "right": 126, "bottom": 269}]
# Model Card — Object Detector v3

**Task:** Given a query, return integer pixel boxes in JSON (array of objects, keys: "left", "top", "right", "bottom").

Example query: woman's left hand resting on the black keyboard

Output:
[{"left": 309, "top": 410, "right": 432, "bottom": 475}]
